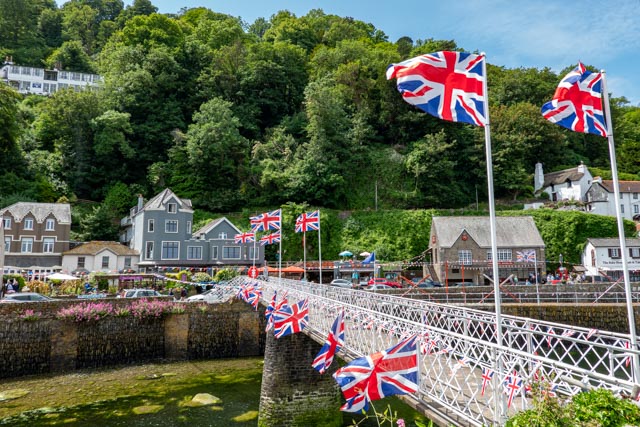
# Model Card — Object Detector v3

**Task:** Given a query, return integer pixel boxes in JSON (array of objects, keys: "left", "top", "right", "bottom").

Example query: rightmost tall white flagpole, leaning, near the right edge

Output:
[{"left": 600, "top": 70, "right": 640, "bottom": 388}]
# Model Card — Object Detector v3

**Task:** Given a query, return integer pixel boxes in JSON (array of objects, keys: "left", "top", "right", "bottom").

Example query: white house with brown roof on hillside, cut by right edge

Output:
[{"left": 585, "top": 177, "right": 640, "bottom": 220}]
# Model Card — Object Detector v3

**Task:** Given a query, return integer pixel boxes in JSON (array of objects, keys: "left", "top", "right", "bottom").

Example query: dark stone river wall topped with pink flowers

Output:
[{"left": 0, "top": 299, "right": 265, "bottom": 378}]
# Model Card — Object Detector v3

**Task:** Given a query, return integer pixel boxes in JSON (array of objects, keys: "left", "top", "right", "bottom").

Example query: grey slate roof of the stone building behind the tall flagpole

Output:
[{"left": 432, "top": 216, "right": 545, "bottom": 248}]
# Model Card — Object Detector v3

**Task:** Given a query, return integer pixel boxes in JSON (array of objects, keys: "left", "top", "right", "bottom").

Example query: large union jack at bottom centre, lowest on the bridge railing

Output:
[{"left": 333, "top": 335, "right": 418, "bottom": 412}]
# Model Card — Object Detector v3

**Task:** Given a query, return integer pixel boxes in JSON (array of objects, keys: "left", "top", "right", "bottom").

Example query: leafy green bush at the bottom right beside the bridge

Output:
[{"left": 506, "top": 389, "right": 640, "bottom": 427}]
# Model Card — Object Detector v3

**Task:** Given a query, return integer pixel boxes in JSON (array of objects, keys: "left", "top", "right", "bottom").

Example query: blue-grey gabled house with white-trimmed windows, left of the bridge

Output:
[{"left": 120, "top": 188, "right": 264, "bottom": 270}]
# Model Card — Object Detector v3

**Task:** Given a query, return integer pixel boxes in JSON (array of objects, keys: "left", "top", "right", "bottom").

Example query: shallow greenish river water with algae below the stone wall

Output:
[{"left": 0, "top": 358, "right": 430, "bottom": 427}]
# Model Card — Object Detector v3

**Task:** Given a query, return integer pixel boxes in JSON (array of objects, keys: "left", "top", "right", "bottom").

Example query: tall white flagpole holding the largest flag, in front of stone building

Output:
[{"left": 480, "top": 52, "right": 506, "bottom": 421}]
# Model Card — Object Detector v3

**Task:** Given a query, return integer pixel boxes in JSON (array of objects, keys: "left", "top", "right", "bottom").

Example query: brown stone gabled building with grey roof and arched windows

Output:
[{"left": 429, "top": 216, "right": 545, "bottom": 285}]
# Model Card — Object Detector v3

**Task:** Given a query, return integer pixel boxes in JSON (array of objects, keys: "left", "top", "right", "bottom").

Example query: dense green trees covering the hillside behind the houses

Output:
[{"left": 0, "top": 0, "right": 640, "bottom": 259}]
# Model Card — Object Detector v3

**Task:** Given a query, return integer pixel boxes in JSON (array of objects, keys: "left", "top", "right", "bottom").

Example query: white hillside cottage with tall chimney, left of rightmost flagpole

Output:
[{"left": 534, "top": 163, "right": 593, "bottom": 202}]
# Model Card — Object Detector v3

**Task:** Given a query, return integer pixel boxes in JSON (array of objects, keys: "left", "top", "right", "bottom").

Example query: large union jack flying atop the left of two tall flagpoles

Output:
[{"left": 387, "top": 51, "right": 486, "bottom": 126}]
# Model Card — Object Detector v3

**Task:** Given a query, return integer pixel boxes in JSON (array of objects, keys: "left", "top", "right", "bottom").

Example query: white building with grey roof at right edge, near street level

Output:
[{"left": 582, "top": 238, "right": 640, "bottom": 282}]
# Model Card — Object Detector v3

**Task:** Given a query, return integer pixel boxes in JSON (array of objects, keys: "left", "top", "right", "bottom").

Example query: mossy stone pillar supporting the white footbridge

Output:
[{"left": 258, "top": 333, "right": 343, "bottom": 427}]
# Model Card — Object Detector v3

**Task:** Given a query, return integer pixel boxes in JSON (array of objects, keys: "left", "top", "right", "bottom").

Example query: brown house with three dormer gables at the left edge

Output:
[{"left": 0, "top": 202, "right": 71, "bottom": 268}]
